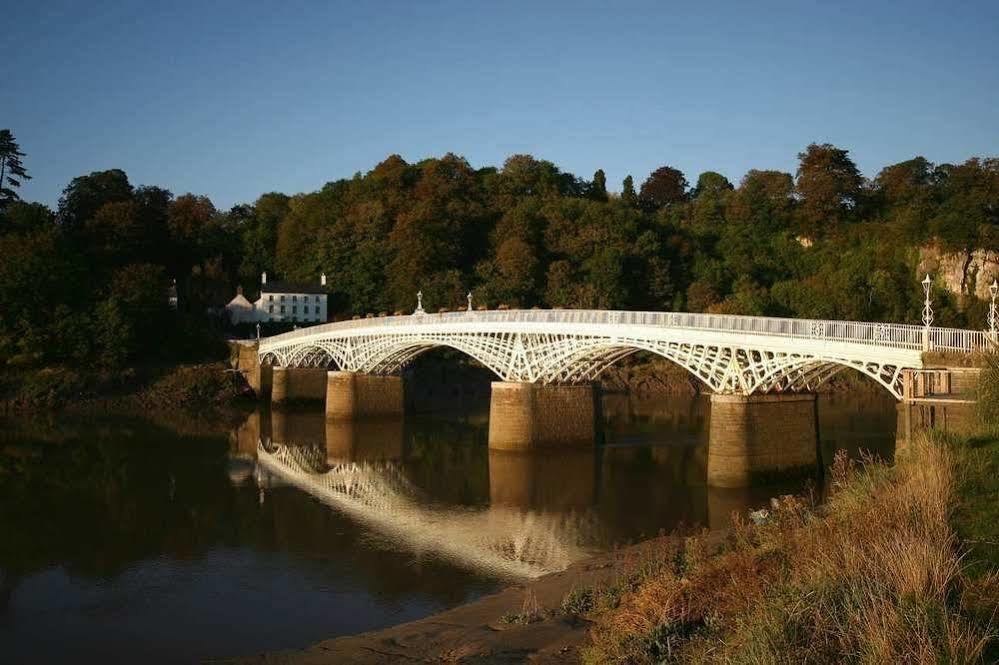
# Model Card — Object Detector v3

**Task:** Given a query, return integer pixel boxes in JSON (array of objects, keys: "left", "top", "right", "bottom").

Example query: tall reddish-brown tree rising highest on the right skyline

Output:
[{"left": 797, "top": 143, "right": 864, "bottom": 237}]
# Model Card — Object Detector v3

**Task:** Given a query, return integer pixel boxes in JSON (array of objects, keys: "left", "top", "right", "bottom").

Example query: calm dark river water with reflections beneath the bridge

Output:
[{"left": 0, "top": 395, "right": 896, "bottom": 663}]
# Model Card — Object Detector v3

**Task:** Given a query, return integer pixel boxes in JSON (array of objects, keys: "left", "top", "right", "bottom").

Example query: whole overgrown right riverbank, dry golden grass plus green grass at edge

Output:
[{"left": 556, "top": 360, "right": 999, "bottom": 663}]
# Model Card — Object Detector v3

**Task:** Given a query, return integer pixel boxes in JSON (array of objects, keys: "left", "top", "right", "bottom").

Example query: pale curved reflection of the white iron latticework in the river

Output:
[{"left": 258, "top": 444, "right": 591, "bottom": 578}]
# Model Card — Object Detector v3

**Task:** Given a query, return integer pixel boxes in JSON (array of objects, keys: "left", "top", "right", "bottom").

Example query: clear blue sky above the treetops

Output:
[{"left": 7, "top": 0, "right": 999, "bottom": 208}]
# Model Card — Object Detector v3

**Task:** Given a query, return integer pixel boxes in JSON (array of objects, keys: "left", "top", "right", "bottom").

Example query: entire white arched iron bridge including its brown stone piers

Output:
[{"left": 254, "top": 310, "right": 994, "bottom": 487}]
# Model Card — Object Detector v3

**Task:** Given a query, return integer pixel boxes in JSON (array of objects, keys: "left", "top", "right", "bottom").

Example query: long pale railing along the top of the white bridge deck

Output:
[{"left": 267, "top": 309, "right": 991, "bottom": 353}]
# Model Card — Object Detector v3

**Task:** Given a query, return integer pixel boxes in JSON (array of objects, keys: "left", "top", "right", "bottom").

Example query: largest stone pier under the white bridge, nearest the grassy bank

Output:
[{"left": 708, "top": 394, "right": 818, "bottom": 487}]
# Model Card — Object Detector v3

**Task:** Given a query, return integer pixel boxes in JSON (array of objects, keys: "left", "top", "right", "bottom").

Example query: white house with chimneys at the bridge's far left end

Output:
[{"left": 225, "top": 272, "right": 326, "bottom": 323}]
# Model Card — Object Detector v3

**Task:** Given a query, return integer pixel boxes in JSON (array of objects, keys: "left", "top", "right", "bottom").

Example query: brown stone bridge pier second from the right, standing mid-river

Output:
[{"left": 489, "top": 381, "right": 596, "bottom": 450}]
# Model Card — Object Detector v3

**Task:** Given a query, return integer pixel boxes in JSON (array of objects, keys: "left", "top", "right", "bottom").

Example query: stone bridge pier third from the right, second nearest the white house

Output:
[{"left": 325, "top": 372, "right": 404, "bottom": 420}]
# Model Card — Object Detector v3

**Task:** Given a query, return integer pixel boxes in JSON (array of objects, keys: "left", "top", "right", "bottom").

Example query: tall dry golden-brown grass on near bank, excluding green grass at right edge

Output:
[{"left": 584, "top": 437, "right": 995, "bottom": 663}]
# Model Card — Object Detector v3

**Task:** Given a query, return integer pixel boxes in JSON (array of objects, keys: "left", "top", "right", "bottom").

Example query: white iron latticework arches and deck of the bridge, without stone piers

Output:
[{"left": 259, "top": 310, "right": 994, "bottom": 399}]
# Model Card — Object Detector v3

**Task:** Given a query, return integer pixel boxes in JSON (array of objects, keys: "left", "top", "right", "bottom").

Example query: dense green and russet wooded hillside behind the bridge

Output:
[{"left": 0, "top": 127, "right": 999, "bottom": 364}]
